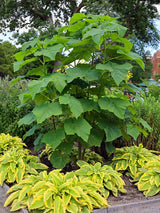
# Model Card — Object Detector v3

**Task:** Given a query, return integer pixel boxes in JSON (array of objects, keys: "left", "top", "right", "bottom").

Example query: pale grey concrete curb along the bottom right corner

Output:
[{"left": 93, "top": 198, "right": 160, "bottom": 213}]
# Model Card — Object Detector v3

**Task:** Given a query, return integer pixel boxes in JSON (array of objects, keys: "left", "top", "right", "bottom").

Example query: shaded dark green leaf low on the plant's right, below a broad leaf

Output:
[{"left": 98, "top": 120, "right": 122, "bottom": 141}]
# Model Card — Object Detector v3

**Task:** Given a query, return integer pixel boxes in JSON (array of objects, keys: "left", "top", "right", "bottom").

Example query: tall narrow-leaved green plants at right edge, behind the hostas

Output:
[{"left": 133, "top": 96, "right": 160, "bottom": 150}]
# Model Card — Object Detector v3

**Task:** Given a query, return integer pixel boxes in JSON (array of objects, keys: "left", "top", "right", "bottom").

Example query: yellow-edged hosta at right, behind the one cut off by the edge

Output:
[{"left": 111, "top": 144, "right": 158, "bottom": 178}]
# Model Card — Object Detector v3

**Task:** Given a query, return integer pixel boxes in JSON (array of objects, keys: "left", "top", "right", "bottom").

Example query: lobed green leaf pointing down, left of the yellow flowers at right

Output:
[{"left": 96, "top": 61, "right": 132, "bottom": 85}]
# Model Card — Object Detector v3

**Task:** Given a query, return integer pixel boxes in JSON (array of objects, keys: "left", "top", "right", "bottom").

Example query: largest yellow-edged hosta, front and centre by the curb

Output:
[{"left": 4, "top": 170, "right": 108, "bottom": 213}]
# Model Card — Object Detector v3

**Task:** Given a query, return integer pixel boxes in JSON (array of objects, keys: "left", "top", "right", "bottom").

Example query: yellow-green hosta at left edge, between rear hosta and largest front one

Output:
[{"left": 0, "top": 148, "right": 48, "bottom": 186}]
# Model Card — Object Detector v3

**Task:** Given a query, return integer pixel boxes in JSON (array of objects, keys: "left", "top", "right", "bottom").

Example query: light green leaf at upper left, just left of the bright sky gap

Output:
[{"left": 34, "top": 44, "right": 63, "bottom": 60}]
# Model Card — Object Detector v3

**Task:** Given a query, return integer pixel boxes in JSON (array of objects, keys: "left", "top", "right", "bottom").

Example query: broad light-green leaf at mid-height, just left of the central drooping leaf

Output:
[{"left": 32, "top": 102, "right": 62, "bottom": 123}]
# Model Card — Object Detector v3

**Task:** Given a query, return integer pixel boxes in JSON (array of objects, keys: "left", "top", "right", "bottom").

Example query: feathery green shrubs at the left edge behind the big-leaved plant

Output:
[{"left": 0, "top": 77, "right": 34, "bottom": 138}]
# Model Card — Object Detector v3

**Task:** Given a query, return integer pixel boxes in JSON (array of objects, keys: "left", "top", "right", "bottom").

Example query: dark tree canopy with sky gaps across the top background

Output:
[{"left": 0, "top": 0, "right": 159, "bottom": 48}]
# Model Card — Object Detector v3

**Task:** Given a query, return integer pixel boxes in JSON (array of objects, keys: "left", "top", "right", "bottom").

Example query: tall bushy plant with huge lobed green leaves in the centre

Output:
[{"left": 14, "top": 13, "right": 144, "bottom": 168}]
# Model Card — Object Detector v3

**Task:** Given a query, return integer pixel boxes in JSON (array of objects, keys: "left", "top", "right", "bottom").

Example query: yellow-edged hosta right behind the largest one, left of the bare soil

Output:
[{"left": 76, "top": 161, "right": 126, "bottom": 198}]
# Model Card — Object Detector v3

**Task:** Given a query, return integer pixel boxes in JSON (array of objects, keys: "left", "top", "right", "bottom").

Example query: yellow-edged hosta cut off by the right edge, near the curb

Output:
[{"left": 135, "top": 161, "right": 160, "bottom": 197}]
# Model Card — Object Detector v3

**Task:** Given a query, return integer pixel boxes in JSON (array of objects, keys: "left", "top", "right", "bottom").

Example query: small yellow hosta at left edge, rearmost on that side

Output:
[{"left": 0, "top": 133, "right": 26, "bottom": 155}]
